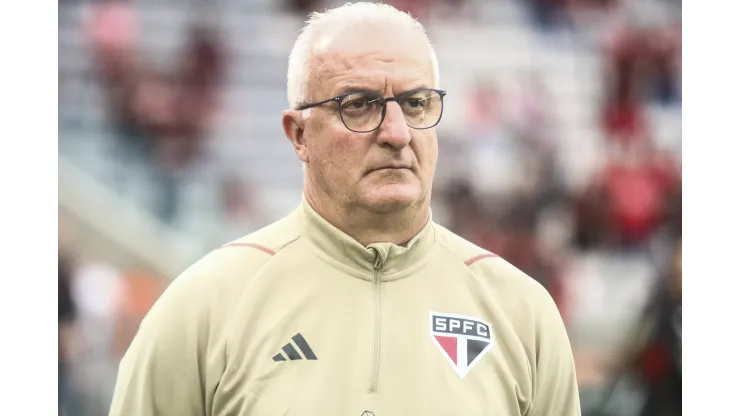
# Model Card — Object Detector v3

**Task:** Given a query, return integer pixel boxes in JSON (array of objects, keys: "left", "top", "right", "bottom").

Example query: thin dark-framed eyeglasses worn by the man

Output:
[{"left": 296, "top": 88, "right": 447, "bottom": 133}]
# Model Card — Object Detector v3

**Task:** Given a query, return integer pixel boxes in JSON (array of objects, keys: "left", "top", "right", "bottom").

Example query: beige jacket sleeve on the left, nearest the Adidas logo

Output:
[{"left": 109, "top": 277, "right": 206, "bottom": 416}]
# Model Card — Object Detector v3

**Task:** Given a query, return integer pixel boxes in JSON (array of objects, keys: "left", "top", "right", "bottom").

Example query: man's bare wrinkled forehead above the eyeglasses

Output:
[{"left": 311, "top": 30, "right": 434, "bottom": 93}]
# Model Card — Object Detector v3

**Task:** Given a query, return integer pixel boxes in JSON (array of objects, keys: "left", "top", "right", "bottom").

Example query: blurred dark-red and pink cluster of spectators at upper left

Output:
[{"left": 84, "top": 1, "right": 224, "bottom": 220}]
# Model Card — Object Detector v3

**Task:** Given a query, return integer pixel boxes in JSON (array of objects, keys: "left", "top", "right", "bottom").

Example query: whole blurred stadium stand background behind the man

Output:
[{"left": 59, "top": 0, "right": 681, "bottom": 416}]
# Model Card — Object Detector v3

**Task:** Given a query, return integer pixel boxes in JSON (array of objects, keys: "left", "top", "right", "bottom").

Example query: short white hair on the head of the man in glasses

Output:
[{"left": 288, "top": 2, "right": 439, "bottom": 108}]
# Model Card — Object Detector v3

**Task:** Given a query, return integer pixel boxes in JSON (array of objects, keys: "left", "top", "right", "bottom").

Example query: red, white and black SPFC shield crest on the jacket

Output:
[{"left": 429, "top": 311, "right": 493, "bottom": 379}]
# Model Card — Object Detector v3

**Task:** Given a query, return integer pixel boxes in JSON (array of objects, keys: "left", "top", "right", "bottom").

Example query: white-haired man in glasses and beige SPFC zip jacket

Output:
[{"left": 111, "top": 3, "right": 580, "bottom": 416}]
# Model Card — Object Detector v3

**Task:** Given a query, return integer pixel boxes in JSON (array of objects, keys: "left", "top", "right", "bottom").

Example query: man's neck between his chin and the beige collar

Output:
[{"left": 304, "top": 182, "right": 429, "bottom": 246}]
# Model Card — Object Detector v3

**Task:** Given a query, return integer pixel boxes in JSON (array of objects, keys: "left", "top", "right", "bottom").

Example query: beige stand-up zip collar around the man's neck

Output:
[{"left": 297, "top": 197, "right": 435, "bottom": 282}]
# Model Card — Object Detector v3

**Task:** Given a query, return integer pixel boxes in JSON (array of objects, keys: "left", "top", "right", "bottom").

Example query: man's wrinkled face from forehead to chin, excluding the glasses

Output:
[{"left": 292, "top": 28, "right": 437, "bottom": 212}]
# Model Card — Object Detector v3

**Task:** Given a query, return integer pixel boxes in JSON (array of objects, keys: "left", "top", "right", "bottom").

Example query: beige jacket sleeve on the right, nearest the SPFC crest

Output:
[{"left": 526, "top": 288, "right": 581, "bottom": 416}]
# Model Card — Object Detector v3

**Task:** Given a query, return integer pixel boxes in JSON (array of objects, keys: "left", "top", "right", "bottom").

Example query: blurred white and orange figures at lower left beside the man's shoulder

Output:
[{"left": 58, "top": 228, "right": 168, "bottom": 416}]
